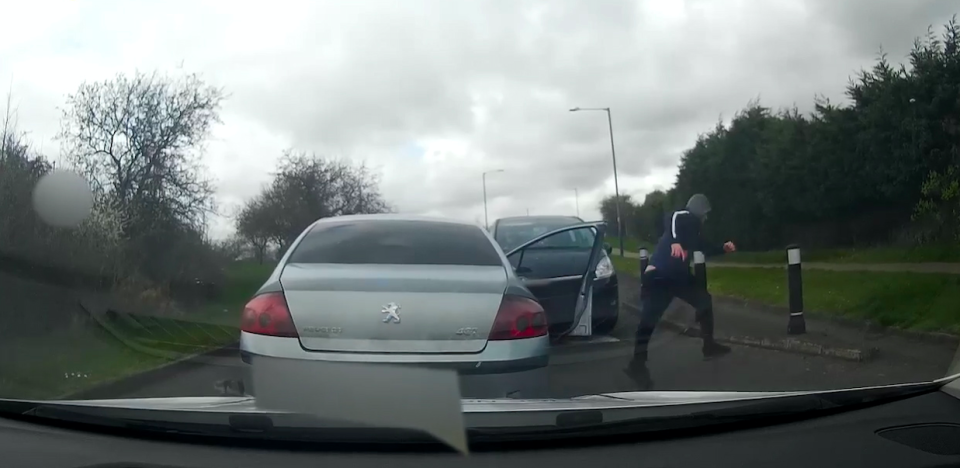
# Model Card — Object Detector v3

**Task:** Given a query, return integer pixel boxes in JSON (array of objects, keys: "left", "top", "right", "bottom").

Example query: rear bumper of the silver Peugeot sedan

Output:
[{"left": 240, "top": 332, "right": 550, "bottom": 398}]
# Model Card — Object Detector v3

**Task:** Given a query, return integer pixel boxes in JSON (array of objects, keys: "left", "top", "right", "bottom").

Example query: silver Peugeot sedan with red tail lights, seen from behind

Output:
[{"left": 240, "top": 214, "right": 600, "bottom": 398}]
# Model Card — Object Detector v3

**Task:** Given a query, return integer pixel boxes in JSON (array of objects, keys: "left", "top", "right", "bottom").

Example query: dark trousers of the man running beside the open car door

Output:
[{"left": 632, "top": 270, "right": 713, "bottom": 365}]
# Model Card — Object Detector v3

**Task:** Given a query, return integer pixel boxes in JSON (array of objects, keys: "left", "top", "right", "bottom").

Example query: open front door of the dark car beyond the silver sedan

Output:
[{"left": 506, "top": 222, "right": 606, "bottom": 338}]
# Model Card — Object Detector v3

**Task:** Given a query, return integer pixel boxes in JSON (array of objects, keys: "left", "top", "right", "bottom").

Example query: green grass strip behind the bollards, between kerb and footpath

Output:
[{"left": 613, "top": 257, "right": 960, "bottom": 334}]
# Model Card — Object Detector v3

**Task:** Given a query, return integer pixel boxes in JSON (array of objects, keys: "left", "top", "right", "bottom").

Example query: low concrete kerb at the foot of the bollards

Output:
[{"left": 624, "top": 302, "right": 878, "bottom": 362}]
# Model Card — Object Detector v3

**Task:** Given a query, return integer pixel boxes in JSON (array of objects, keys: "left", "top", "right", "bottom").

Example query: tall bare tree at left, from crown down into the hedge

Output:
[{"left": 59, "top": 72, "right": 224, "bottom": 282}]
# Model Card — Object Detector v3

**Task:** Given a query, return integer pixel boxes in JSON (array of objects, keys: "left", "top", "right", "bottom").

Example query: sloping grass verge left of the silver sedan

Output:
[{"left": 0, "top": 263, "right": 272, "bottom": 399}]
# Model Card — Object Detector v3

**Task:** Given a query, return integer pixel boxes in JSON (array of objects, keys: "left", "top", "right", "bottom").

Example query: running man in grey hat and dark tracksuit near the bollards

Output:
[{"left": 624, "top": 193, "right": 737, "bottom": 390}]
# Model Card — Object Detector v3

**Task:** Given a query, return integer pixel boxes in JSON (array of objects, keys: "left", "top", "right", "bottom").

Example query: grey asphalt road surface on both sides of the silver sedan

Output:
[{"left": 95, "top": 311, "right": 942, "bottom": 398}]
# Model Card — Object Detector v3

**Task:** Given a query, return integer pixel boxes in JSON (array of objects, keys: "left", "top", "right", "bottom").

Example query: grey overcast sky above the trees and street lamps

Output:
[{"left": 0, "top": 0, "right": 960, "bottom": 236}]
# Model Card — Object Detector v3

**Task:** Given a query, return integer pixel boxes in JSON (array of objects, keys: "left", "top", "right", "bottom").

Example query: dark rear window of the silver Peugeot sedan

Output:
[{"left": 289, "top": 221, "right": 503, "bottom": 266}]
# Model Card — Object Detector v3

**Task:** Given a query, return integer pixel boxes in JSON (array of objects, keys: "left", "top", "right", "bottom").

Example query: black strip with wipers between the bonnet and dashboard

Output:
[{"left": 0, "top": 381, "right": 944, "bottom": 451}]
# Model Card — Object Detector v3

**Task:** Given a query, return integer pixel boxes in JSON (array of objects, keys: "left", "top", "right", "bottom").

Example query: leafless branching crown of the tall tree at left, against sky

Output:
[{"left": 60, "top": 72, "right": 224, "bottom": 235}]
